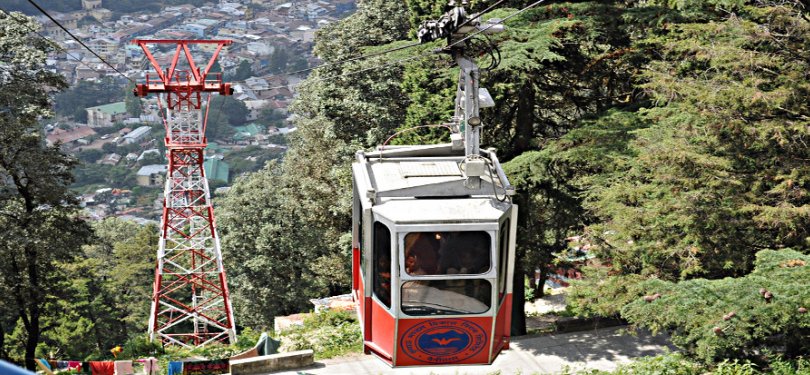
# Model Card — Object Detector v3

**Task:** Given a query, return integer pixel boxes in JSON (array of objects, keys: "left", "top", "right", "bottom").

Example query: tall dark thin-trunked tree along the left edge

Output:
[{"left": 0, "top": 13, "right": 91, "bottom": 370}]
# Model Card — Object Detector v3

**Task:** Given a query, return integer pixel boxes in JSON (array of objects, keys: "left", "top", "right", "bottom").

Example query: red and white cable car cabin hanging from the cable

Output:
[{"left": 352, "top": 145, "right": 517, "bottom": 366}]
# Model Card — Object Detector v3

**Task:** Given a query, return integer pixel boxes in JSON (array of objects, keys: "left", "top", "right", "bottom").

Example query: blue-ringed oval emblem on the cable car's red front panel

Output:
[{"left": 400, "top": 319, "right": 487, "bottom": 364}]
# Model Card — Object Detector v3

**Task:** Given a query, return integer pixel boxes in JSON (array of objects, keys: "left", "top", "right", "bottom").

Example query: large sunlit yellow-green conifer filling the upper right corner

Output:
[{"left": 560, "top": 3, "right": 810, "bottom": 290}]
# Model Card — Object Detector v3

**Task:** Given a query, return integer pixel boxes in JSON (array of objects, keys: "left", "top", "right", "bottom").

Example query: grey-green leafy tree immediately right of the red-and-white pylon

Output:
[{"left": 217, "top": 163, "right": 333, "bottom": 328}]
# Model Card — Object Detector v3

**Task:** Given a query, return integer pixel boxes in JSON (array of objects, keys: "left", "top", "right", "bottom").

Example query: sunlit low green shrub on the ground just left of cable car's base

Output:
[{"left": 279, "top": 310, "right": 363, "bottom": 359}]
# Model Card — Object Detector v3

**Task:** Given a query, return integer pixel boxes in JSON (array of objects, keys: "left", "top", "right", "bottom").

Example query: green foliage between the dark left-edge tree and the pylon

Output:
[{"left": 43, "top": 218, "right": 157, "bottom": 359}]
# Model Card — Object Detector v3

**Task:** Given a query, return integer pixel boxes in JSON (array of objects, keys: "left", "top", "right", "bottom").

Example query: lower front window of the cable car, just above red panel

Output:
[{"left": 401, "top": 279, "right": 492, "bottom": 316}]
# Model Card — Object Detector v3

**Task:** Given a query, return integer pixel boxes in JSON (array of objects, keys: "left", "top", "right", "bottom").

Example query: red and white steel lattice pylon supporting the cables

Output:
[{"left": 133, "top": 40, "right": 236, "bottom": 347}]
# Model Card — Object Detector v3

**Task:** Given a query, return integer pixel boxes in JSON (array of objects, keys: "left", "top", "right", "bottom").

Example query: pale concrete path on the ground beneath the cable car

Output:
[{"left": 262, "top": 327, "right": 675, "bottom": 375}]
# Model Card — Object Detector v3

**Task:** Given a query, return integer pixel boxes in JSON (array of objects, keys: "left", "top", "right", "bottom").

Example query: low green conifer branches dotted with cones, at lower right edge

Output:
[{"left": 621, "top": 250, "right": 810, "bottom": 363}]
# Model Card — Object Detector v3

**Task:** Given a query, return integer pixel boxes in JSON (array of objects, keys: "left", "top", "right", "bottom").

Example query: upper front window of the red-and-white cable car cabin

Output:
[{"left": 405, "top": 231, "right": 492, "bottom": 276}]
